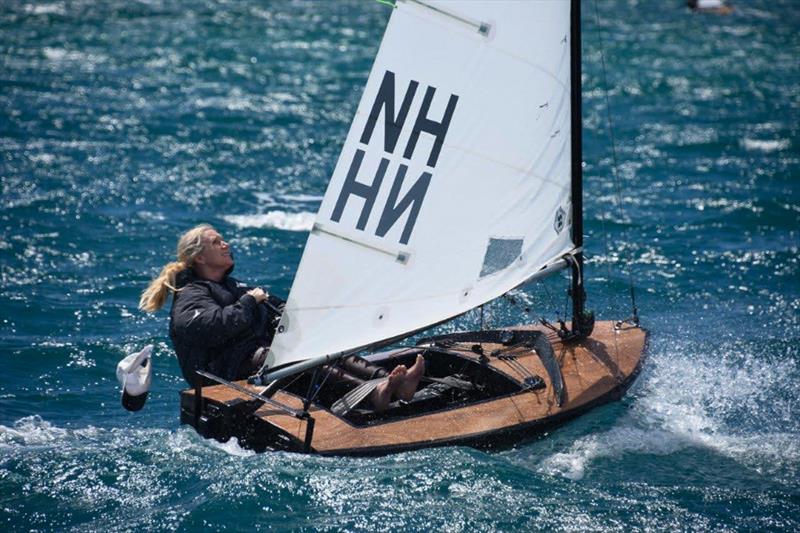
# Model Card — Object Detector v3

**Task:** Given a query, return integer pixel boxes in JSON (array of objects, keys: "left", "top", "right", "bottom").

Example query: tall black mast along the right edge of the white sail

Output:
[{"left": 570, "top": 0, "right": 586, "bottom": 334}]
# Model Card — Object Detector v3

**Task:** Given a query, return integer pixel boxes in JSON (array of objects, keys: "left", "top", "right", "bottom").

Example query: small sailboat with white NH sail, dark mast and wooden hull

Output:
[{"left": 181, "top": 0, "right": 647, "bottom": 455}]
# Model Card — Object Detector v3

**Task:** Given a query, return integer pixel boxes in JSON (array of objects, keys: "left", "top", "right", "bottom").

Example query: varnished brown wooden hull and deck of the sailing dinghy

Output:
[{"left": 181, "top": 322, "right": 647, "bottom": 455}]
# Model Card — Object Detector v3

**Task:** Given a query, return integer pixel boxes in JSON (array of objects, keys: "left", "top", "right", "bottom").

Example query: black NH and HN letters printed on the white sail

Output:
[{"left": 331, "top": 70, "right": 458, "bottom": 244}]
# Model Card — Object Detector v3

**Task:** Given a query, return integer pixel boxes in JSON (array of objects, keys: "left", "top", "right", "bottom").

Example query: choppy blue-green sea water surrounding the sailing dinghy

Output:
[{"left": 0, "top": 0, "right": 800, "bottom": 531}]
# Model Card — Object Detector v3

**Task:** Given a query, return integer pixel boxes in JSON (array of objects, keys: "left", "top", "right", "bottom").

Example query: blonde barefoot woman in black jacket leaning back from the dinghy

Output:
[{"left": 139, "top": 224, "right": 425, "bottom": 410}]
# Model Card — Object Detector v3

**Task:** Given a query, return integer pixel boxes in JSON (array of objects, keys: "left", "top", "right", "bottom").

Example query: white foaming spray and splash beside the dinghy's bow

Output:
[{"left": 539, "top": 343, "right": 800, "bottom": 486}]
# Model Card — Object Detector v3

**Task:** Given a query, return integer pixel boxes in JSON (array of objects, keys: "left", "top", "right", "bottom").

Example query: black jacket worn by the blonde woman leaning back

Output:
[{"left": 169, "top": 269, "right": 284, "bottom": 386}]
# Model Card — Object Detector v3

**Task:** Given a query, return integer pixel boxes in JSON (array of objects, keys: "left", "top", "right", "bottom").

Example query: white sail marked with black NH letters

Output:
[{"left": 268, "top": 0, "right": 574, "bottom": 367}]
